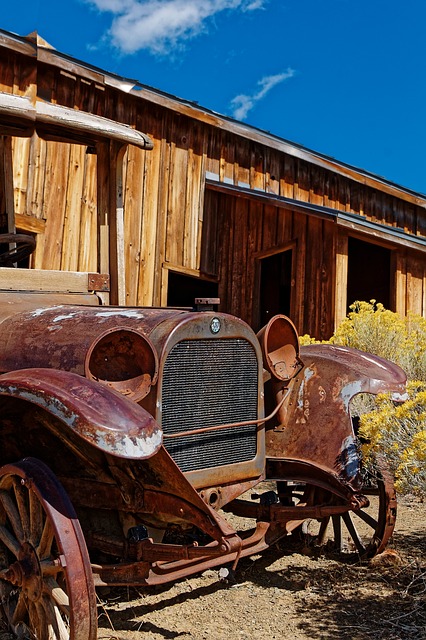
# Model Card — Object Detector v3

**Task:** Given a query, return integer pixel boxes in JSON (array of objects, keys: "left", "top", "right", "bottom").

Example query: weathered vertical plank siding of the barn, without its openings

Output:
[{"left": 0, "top": 32, "right": 426, "bottom": 337}]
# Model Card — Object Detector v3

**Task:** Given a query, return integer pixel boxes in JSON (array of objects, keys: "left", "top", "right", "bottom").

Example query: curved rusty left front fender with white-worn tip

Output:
[{"left": 0, "top": 368, "right": 162, "bottom": 460}]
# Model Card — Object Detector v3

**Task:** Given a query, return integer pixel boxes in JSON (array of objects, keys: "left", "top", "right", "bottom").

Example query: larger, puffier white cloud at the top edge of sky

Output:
[{"left": 86, "top": 0, "right": 269, "bottom": 54}]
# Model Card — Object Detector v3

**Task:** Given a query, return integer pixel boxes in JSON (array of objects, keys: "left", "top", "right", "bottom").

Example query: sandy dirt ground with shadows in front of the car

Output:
[{"left": 98, "top": 498, "right": 426, "bottom": 640}]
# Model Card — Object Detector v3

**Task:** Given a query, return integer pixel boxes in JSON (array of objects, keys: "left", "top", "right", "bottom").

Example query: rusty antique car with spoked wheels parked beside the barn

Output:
[{"left": 0, "top": 91, "right": 405, "bottom": 640}]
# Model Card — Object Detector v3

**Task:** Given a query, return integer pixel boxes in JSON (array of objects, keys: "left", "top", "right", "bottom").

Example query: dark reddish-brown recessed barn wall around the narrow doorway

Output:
[{"left": 202, "top": 191, "right": 336, "bottom": 338}]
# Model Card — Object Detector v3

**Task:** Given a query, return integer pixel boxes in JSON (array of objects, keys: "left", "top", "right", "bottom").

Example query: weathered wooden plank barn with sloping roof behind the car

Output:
[{"left": 0, "top": 32, "right": 426, "bottom": 338}]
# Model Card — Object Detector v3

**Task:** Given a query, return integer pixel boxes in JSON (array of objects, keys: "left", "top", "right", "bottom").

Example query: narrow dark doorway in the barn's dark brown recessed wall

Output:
[{"left": 260, "top": 249, "right": 293, "bottom": 327}]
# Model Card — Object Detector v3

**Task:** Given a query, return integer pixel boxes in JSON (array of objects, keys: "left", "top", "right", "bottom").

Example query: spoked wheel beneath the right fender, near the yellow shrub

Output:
[{"left": 280, "top": 460, "right": 396, "bottom": 558}]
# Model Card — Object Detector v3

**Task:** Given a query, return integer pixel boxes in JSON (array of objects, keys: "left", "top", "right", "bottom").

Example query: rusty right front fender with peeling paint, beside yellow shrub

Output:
[{"left": 266, "top": 345, "right": 406, "bottom": 488}]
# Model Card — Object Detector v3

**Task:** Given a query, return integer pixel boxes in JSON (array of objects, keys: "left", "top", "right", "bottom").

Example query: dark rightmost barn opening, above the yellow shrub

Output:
[{"left": 347, "top": 238, "right": 392, "bottom": 310}]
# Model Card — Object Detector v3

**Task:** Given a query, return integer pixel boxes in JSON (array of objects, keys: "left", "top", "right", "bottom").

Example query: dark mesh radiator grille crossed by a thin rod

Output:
[{"left": 161, "top": 338, "right": 258, "bottom": 471}]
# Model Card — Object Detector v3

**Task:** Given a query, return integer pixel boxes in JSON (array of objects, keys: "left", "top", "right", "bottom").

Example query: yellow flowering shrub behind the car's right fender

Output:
[{"left": 302, "top": 300, "right": 426, "bottom": 496}]
